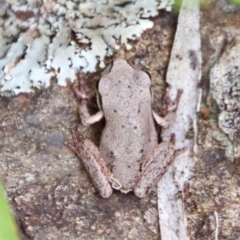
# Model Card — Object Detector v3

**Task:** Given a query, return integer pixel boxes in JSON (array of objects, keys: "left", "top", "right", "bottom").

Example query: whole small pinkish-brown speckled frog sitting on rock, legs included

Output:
[{"left": 67, "top": 58, "right": 182, "bottom": 198}]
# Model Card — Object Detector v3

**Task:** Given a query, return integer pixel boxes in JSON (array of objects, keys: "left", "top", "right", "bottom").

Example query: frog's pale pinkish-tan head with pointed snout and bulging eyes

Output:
[{"left": 98, "top": 58, "right": 151, "bottom": 113}]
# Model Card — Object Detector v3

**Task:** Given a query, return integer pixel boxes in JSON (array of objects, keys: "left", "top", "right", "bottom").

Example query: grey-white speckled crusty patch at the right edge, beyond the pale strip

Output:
[{"left": 210, "top": 36, "right": 240, "bottom": 161}]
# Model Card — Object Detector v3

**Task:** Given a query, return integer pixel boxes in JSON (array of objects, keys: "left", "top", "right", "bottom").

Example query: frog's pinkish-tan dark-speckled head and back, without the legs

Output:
[{"left": 99, "top": 59, "right": 157, "bottom": 191}]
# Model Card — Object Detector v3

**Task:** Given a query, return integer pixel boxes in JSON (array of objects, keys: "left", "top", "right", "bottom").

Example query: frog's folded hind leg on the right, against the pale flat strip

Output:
[{"left": 134, "top": 142, "right": 174, "bottom": 198}]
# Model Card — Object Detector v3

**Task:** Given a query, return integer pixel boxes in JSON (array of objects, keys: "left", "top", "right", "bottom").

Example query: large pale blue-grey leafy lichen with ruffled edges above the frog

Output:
[{"left": 0, "top": 0, "right": 172, "bottom": 94}]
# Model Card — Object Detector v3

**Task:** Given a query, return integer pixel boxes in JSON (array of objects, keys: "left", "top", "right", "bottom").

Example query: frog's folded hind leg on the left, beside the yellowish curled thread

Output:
[{"left": 79, "top": 139, "right": 112, "bottom": 198}]
